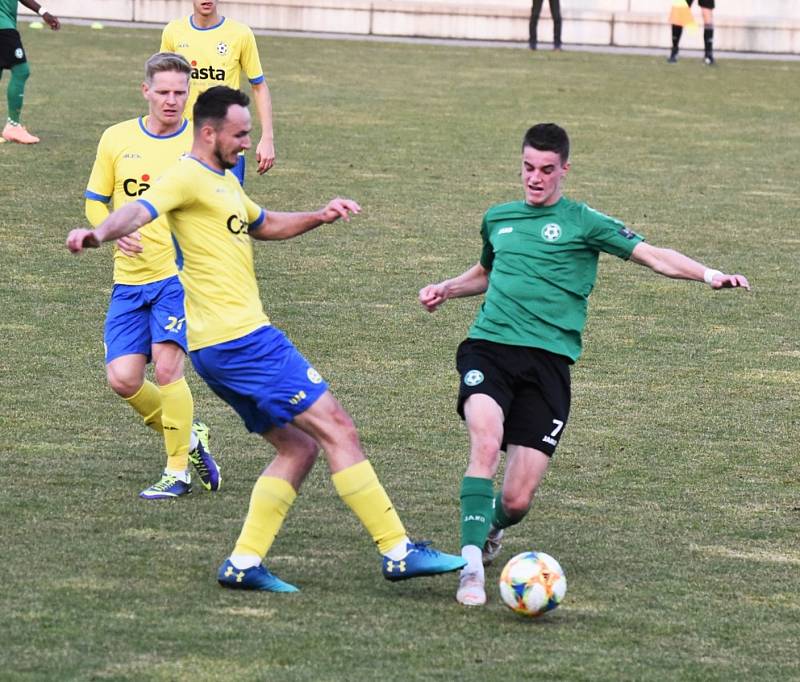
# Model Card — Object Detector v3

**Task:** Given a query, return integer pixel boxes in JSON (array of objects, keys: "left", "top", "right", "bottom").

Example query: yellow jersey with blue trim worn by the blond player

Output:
[{"left": 84, "top": 117, "right": 192, "bottom": 284}]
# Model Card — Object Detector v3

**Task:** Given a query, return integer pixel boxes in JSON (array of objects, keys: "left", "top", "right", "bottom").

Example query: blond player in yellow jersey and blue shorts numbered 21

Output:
[{"left": 84, "top": 52, "right": 220, "bottom": 499}]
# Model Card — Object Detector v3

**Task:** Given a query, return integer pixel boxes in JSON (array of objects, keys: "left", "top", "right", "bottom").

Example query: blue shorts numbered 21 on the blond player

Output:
[{"left": 103, "top": 275, "right": 188, "bottom": 364}]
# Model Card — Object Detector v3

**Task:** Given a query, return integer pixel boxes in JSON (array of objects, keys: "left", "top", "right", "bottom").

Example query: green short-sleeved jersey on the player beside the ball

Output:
[{"left": 469, "top": 197, "right": 642, "bottom": 362}]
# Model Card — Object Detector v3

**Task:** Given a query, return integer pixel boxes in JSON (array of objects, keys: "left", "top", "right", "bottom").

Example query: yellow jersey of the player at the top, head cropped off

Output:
[{"left": 161, "top": 15, "right": 264, "bottom": 117}]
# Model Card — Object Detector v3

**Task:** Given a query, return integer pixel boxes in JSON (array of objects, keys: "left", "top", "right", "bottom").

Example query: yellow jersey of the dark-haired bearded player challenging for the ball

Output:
[{"left": 139, "top": 156, "right": 270, "bottom": 351}]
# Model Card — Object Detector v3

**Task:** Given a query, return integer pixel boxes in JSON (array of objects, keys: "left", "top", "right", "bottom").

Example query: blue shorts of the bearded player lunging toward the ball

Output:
[{"left": 189, "top": 325, "right": 328, "bottom": 433}]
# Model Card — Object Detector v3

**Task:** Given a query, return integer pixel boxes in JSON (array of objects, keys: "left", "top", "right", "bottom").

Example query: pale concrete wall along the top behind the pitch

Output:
[{"left": 20, "top": 0, "right": 800, "bottom": 54}]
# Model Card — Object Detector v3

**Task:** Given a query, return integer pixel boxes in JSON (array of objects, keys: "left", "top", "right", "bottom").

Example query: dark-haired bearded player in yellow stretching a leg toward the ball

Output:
[{"left": 67, "top": 86, "right": 466, "bottom": 592}]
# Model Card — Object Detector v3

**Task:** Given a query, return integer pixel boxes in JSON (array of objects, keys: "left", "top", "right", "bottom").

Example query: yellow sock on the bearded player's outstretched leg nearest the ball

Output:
[{"left": 331, "top": 459, "right": 406, "bottom": 554}]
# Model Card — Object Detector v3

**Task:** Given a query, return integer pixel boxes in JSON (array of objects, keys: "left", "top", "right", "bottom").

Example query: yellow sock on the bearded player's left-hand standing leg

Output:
[{"left": 233, "top": 476, "right": 297, "bottom": 559}]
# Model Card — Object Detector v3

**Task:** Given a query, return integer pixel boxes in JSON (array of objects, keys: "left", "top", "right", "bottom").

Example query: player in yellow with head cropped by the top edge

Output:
[{"left": 161, "top": 0, "right": 275, "bottom": 184}]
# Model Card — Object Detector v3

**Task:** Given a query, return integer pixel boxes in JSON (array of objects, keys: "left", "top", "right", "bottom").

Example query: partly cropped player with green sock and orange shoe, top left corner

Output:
[{"left": 0, "top": 0, "right": 61, "bottom": 144}]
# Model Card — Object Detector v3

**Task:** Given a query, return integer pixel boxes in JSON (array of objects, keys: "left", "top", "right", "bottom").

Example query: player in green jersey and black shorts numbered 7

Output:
[{"left": 419, "top": 123, "right": 750, "bottom": 606}]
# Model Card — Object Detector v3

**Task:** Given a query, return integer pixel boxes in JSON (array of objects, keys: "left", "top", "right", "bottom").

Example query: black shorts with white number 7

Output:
[{"left": 456, "top": 339, "right": 570, "bottom": 455}]
